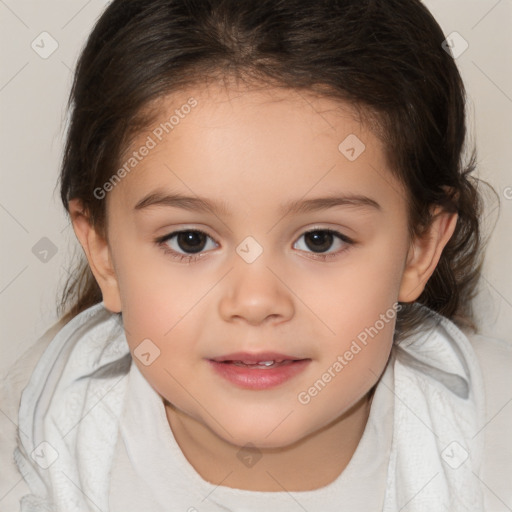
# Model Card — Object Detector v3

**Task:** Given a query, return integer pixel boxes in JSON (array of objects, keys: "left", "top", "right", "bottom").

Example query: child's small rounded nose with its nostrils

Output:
[{"left": 219, "top": 258, "right": 295, "bottom": 325}]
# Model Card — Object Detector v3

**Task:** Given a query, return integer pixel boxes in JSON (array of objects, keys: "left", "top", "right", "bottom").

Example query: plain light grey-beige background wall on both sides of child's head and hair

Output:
[{"left": 0, "top": 0, "right": 512, "bottom": 373}]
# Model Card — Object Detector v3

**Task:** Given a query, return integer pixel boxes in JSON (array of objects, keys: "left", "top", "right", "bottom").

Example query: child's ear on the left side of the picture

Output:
[{"left": 69, "top": 199, "right": 121, "bottom": 313}]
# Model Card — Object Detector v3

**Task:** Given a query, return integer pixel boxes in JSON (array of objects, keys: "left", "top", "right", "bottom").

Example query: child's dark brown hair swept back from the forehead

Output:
[{"left": 59, "top": 0, "right": 496, "bottom": 337}]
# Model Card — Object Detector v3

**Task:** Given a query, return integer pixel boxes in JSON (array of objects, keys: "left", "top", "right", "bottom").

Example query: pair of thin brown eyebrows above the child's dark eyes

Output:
[{"left": 134, "top": 190, "right": 382, "bottom": 217}]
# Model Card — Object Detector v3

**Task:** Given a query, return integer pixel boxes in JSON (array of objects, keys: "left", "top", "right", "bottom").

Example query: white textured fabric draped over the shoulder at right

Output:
[{"left": 383, "top": 315, "right": 485, "bottom": 512}]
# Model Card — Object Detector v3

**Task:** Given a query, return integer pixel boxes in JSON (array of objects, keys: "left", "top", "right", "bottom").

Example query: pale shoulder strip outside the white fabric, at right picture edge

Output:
[{"left": 465, "top": 332, "right": 512, "bottom": 511}]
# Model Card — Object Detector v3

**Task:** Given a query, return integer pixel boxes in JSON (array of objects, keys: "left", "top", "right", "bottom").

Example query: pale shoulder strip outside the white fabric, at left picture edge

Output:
[{"left": 0, "top": 322, "right": 64, "bottom": 511}]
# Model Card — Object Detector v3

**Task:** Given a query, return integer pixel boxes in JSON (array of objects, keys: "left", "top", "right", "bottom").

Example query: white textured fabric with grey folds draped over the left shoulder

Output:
[{"left": 14, "top": 303, "right": 130, "bottom": 512}]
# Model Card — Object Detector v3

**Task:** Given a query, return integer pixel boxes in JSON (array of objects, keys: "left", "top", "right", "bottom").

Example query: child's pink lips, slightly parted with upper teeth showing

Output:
[{"left": 208, "top": 352, "right": 311, "bottom": 390}]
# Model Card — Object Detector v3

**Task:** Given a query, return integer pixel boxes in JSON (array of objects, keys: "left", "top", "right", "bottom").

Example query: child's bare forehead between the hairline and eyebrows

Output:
[{"left": 107, "top": 83, "right": 399, "bottom": 217}]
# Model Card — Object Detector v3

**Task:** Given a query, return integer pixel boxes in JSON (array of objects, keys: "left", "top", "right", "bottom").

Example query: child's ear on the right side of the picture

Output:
[{"left": 398, "top": 207, "right": 457, "bottom": 302}]
